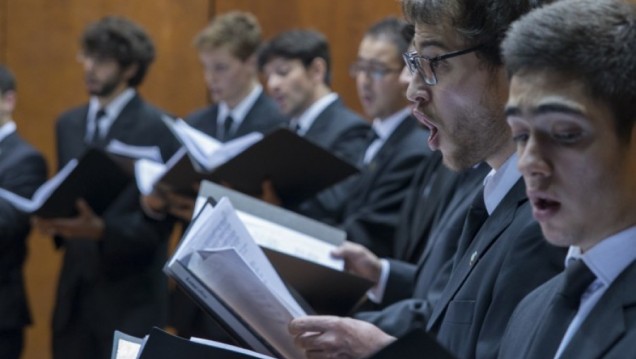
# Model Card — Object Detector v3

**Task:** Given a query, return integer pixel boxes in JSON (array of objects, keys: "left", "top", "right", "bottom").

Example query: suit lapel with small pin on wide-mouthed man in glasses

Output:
[{"left": 428, "top": 179, "right": 527, "bottom": 329}]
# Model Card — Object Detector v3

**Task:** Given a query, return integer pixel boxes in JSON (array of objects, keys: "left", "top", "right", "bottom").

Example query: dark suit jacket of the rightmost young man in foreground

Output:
[{"left": 499, "top": 262, "right": 636, "bottom": 359}]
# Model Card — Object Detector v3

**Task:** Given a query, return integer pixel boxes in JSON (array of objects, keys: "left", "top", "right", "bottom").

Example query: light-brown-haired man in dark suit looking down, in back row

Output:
[{"left": 149, "top": 11, "right": 287, "bottom": 339}]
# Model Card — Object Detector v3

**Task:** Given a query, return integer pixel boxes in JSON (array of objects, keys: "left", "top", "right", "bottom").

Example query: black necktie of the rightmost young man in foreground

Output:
[{"left": 527, "top": 259, "right": 596, "bottom": 359}]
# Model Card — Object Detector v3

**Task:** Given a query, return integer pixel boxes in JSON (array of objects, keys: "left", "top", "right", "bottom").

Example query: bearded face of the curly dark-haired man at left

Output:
[{"left": 77, "top": 52, "right": 133, "bottom": 97}]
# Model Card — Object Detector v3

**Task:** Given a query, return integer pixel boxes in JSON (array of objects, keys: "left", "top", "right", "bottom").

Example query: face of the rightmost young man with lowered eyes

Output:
[{"left": 506, "top": 71, "right": 636, "bottom": 250}]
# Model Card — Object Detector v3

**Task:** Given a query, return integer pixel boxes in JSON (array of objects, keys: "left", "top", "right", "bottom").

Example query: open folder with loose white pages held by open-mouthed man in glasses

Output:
[{"left": 164, "top": 198, "right": 306, "bottom": 359}]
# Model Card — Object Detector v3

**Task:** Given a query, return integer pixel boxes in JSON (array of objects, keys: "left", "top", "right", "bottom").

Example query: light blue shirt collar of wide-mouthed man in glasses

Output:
[{"left": 484, "top": 153, "right": 521, "bottom": 215}]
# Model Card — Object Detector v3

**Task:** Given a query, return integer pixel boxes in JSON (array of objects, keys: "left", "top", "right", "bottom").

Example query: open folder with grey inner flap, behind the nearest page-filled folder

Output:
[{"left": 199, "top": 181, "right": 373, "bottom": 315}]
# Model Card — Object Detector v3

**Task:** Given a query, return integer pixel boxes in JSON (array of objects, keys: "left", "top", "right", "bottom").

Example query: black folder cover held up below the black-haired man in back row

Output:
[{"left": 159, "top": 128, "right": 358, "bottom": 203}]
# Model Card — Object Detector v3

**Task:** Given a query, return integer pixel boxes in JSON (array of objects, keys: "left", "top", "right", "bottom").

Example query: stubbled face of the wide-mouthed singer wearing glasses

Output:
[{"left": 407, "top": 24, "right": 510, "bottom": 170}]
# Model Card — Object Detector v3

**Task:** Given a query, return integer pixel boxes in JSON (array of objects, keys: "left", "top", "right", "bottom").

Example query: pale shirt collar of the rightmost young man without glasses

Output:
[{"left": 565, "top": 226, "right": 636, "bottom": 286}]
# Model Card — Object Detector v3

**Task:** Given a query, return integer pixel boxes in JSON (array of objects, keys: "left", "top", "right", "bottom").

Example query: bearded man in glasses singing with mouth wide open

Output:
[{"left": 290, "top": 0, "right": 564, "bottom": 359}]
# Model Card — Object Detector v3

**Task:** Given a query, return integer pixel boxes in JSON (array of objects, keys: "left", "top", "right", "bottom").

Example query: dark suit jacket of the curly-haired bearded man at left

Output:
[{"left": 53, "top": 95, "right": 179, "bottom": 340}]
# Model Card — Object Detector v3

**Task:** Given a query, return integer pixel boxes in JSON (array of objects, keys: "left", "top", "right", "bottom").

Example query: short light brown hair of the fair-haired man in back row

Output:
[{"left": 194, "top": 11, "right": 261, "bottom": 61}]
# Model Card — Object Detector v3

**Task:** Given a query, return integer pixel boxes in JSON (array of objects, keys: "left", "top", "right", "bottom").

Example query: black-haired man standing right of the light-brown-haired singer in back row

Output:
[{"left": 258, "top": 30, "right": 369, "bottom": 167}]
